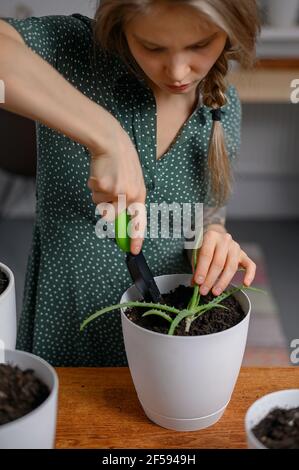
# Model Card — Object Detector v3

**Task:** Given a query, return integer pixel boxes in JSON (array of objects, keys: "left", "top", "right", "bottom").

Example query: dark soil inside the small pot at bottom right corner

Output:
[{"left": 252, "top": 407, "right": 299, "bottom": 449}]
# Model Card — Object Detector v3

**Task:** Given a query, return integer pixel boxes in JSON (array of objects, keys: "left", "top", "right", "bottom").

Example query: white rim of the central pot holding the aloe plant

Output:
[{"left": 120, "top": 273, "right": 251, "bottom": 341}]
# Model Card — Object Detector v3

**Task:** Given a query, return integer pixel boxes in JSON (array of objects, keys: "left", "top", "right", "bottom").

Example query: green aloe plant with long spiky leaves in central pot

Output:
[{"left": 80, "top": 230, "right": 265, "bottom": 335}]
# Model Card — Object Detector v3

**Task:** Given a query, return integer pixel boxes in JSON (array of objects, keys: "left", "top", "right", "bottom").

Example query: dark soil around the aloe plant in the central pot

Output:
[{"left": 125, "top": 284, "right": 245, "bottom": 336}]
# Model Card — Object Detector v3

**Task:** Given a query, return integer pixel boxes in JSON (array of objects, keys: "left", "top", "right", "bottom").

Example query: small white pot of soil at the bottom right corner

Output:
[{"left": 245, "top": 388, "right": 299, "bottom": 449}]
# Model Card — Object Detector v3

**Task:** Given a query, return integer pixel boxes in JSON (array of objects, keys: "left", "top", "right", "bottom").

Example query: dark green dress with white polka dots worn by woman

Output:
[{"left": 2, "top": 14, "right": 241, "bottom": 367}]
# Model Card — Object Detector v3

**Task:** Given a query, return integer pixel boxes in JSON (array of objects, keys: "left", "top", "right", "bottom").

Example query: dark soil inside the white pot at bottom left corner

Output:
[{"left": 0, "top": 364, "right": 50, "bottom": 425}]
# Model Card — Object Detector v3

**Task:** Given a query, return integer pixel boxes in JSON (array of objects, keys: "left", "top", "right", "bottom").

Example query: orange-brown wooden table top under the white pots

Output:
[{"left": 56, "top": 366, "right": 299, "bottom": 449}]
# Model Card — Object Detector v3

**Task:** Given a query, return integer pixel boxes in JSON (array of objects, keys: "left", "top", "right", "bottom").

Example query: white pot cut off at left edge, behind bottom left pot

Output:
[{"left": 0, "top": 263, "right": 17, "bottom": 349}]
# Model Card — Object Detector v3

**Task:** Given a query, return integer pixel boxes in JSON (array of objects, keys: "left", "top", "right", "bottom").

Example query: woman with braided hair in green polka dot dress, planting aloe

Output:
[{"left": 0, "top": 0, "right": 259, "bottom": 366}]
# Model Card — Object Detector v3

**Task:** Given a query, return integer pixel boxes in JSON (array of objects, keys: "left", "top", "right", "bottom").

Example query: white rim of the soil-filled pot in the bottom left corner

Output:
[{"left": 0, "top": 349, "right": 59, "bottom": 434}]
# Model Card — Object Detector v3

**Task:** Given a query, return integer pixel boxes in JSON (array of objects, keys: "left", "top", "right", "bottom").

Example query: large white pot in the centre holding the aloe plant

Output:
[{"left": 120, "top": 274, "right": 251, "bottom": 431}]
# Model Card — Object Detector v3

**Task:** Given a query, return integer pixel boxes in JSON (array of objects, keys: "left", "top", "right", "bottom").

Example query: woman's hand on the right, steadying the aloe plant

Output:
[{"left": 192, "top": 229, "right": 256, "bottom": 296}]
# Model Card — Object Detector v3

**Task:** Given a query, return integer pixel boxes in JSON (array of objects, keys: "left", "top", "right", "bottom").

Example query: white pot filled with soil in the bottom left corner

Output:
[{"left": 0, "top": 350, "right": 58, "bottom": 449}]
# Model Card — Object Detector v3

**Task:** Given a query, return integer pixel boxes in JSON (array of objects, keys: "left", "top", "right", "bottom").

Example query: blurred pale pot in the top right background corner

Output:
[{"left": 268, "top": 0, "right": 299, "bottom": 28}]
